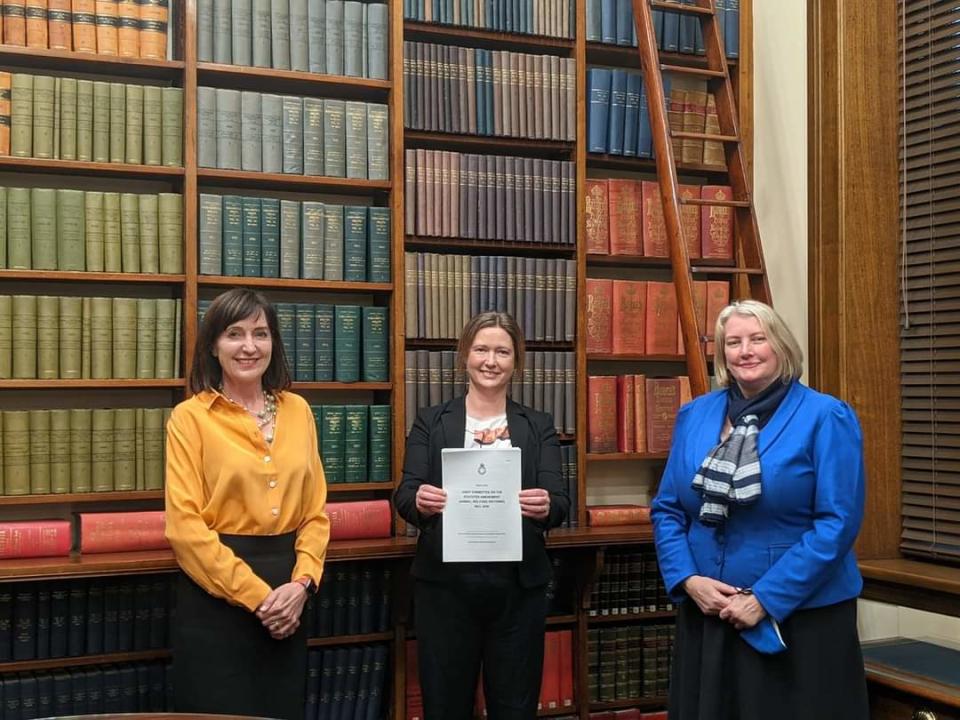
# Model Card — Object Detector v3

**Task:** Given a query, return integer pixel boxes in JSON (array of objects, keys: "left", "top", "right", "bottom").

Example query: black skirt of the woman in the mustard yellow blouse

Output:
[{"left": 173, "top": 533, "right": 307, "bottom": 720}]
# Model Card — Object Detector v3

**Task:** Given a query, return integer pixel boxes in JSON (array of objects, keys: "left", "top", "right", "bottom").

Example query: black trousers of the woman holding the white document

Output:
[{"left": 414, "top": 564, "right": 547, "bottom": 720}]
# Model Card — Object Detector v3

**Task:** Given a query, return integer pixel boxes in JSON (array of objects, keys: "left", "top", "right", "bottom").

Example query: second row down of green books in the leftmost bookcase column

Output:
[{"left": 0, "top": 187, "right": 183, "bottom": 273}]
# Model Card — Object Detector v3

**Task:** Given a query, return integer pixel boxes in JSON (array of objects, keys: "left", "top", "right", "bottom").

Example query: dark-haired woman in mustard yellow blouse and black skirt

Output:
[{"left": 166, "top": 289, "right": 330, "bottom": 720}]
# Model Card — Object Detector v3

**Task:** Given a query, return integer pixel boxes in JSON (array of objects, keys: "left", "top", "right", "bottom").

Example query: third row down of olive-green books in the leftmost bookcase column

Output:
[{"left": 0, "top": 295, "right": 181, "bottom": 380}]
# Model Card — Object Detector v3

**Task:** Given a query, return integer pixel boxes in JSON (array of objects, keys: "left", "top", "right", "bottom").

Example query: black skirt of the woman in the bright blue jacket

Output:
[{"left": 668, "top": 599, "right": 870, "bottom": 720}]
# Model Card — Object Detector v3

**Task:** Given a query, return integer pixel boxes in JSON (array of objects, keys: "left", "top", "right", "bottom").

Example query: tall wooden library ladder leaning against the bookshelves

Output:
[{"left": 633, "top": 0, "right": 770, "bottom": 396}]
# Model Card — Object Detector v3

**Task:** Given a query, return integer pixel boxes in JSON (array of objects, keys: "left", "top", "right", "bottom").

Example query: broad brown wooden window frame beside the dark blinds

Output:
[{"left": 808, "top": 0, "right": 900, "bottom": 559}]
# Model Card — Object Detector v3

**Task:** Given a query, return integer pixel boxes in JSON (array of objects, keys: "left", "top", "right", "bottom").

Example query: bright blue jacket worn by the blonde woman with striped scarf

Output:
[{"left": 651, "top": 382, "right": 864, "bottom": 622}]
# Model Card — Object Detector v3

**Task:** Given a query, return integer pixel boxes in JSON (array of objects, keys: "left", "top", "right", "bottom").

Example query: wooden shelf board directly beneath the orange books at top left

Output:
[{"left": 0, "top": 45, "right": 184, "bottom": 79}]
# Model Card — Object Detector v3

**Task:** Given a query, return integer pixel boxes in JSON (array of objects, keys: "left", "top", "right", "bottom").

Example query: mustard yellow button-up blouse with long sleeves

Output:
[{"left": 166, "top": 390, "right": 330, "bottom": 612}]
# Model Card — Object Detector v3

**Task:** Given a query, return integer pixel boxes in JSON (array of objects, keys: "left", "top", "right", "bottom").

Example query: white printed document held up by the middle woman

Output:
[{"left": 441, "top": 448, "right": 523, "bottom": 562}]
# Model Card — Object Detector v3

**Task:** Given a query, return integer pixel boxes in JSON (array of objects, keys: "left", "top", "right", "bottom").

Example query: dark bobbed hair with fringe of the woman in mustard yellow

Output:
[{"left": 190, "top": 288, "right": 290, "bottom": 393}]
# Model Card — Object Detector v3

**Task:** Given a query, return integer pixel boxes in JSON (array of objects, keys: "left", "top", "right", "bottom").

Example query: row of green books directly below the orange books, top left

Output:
[{"left": 0, "top": 73, "right": 183, "bottom": 167}]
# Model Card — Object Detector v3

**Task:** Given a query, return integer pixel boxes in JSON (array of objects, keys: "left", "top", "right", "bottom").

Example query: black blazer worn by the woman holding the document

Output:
[{"left": 393, "top": 396, "right": 570, "bottom": 588}]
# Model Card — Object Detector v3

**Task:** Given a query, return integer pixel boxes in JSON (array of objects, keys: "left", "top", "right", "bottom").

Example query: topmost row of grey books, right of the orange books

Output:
[{"left": 197, "top": 0, "right": 390, "bottom": 80}]
